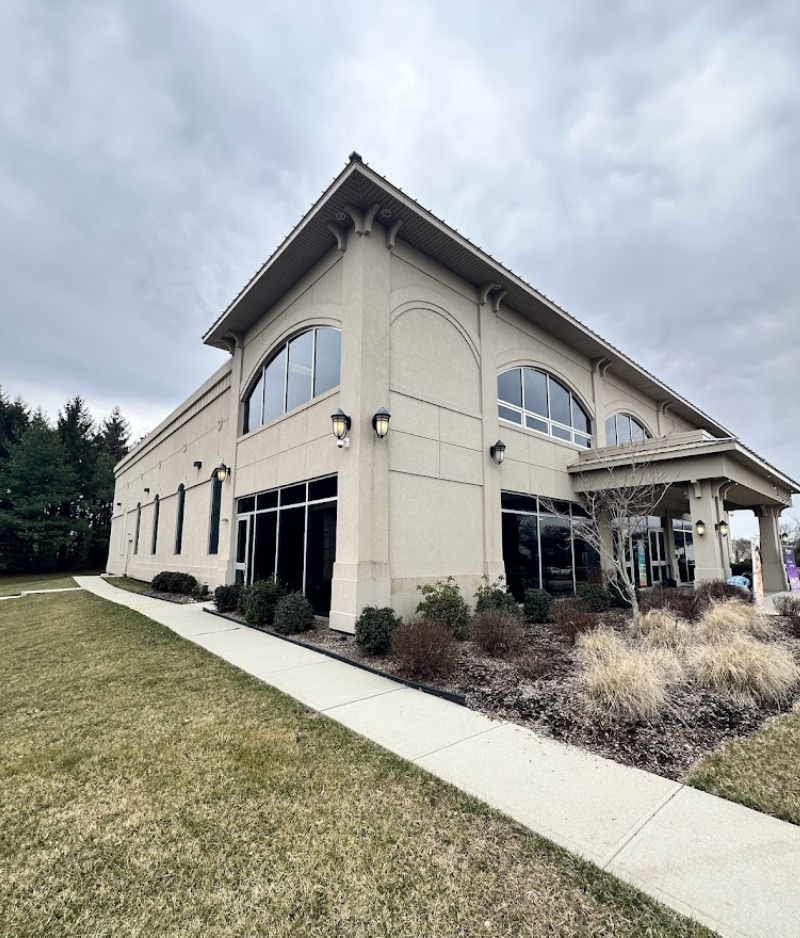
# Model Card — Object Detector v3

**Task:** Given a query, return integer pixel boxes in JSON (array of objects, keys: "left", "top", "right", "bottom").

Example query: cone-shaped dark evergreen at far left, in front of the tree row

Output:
[{"left": 0, "top": 411, "right": 77, "bottom": 570}]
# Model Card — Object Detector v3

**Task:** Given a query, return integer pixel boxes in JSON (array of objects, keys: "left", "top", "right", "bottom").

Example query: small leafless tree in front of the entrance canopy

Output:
[{"left": 540, "top": 442, "right": 671, "bottom": 637}]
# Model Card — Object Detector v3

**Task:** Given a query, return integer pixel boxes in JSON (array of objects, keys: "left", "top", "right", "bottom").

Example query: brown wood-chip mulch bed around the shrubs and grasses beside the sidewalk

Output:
[{"left": 217, "top": 611, "right": 800, "bottom": 780}]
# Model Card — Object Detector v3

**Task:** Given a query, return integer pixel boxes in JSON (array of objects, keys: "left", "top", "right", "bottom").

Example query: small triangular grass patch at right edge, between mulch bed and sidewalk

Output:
[{"left": 687, "top": 705, "right": 800, "bottom": 824}]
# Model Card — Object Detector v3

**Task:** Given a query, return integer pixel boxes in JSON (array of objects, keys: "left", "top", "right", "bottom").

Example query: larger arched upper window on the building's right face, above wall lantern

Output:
[{"left": 497, "top": 368, "right": 592, "bottom": 449}]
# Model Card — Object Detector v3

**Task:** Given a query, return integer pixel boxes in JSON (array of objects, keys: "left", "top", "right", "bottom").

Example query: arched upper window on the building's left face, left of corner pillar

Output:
[{"left": 242, "top": 326, "right": 342, "bottom": 433}]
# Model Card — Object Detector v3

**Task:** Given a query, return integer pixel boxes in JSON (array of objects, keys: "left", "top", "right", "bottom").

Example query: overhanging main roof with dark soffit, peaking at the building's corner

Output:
[{"left": 203, "top": 153, "right": 733, "bottom": 437}]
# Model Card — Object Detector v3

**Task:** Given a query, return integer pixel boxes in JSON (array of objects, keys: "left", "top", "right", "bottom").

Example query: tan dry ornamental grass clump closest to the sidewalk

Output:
[{"left": 578, "top": 629, "right": 683, "bottom": 720}]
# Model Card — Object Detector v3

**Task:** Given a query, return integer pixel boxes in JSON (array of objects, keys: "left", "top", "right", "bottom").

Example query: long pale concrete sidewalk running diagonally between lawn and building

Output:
[{"left": 76, "top": 577, "right": 800, "bottom": 938}]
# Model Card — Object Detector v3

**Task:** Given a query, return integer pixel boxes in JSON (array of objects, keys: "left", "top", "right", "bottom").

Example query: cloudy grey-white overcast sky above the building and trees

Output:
[{"left": 0, "top": 0, "right": 800, "bottom": 531}]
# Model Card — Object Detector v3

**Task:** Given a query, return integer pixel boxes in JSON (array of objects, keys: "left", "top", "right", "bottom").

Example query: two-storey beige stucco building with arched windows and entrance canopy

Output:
[{"left": 108, "top": 154, "right": 798, "bottom": 631}]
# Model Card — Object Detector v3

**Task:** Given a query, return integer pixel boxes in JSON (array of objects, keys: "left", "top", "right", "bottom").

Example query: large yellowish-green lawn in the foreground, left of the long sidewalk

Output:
[{"left": 0, "top": 593, "right": 710, "bottom": 938}]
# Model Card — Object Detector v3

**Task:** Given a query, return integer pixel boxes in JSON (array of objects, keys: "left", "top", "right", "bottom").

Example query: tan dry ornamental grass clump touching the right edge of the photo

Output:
[{"left": 689, "top": 633, "right": 800, "bottom": 704}]
